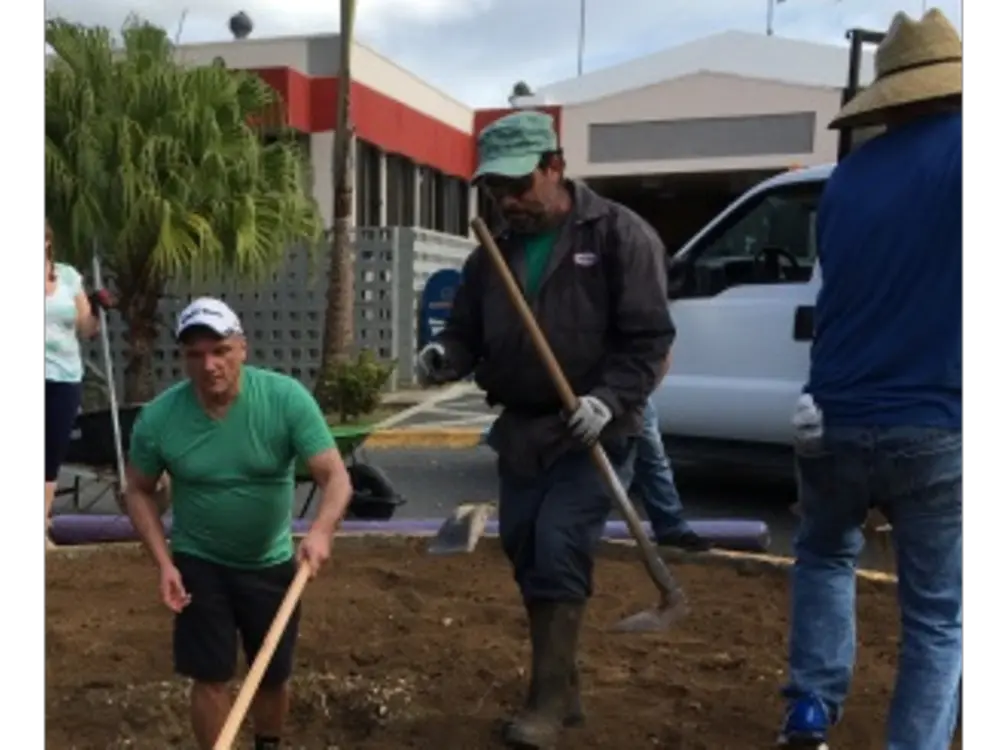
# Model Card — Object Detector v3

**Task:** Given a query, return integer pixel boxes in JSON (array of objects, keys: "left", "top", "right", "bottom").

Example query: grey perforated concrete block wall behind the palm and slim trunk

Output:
[{"left": 84, "top": 227, "right": 474, "bottom": 393}]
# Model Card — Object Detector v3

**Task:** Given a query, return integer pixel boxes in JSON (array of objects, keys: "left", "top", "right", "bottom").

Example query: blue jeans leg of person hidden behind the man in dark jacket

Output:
[{"left": 632, "top": 401, "right": 689, "bottom": 538}]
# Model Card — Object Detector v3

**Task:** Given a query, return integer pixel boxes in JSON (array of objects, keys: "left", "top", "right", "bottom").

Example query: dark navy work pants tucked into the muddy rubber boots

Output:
[{"left": 498, "top": 439, "right": 636, "bottom": 602}]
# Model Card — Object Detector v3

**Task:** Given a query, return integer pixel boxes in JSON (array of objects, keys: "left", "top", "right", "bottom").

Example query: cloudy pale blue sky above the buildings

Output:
[{"left": 45, "top": 0, "right": 968, "bottom": 107}]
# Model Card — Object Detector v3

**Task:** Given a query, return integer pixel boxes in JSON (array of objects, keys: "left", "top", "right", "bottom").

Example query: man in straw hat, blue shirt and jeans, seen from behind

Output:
[{"left": 779, "top": 10, "right": 965, "bottom": 750}]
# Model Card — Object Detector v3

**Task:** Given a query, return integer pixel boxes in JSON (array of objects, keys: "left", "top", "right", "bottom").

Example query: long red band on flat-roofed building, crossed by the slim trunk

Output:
[{"left": 245, "top": 68, "right": 476, "bottom": 179}]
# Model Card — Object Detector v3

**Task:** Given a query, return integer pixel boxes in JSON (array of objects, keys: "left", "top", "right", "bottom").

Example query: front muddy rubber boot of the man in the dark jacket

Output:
[{"left": 504, "top": 602, "right": 584, "bottom": 750}]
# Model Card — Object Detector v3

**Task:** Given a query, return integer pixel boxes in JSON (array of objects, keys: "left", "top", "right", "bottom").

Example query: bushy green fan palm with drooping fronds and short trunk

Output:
[{"left": 43, "top": 17, "right": 323, "bottom": 403}]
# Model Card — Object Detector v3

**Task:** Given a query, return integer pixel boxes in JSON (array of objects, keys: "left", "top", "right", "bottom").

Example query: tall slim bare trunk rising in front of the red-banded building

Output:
[{"left": 317, "top": 0, "right": 357, "bottom": 378}]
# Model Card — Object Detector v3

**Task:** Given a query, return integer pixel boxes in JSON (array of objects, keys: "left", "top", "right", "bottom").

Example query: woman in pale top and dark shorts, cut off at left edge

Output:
[{"left": 42, "top": 219, "right": 114, "bottom": 548}]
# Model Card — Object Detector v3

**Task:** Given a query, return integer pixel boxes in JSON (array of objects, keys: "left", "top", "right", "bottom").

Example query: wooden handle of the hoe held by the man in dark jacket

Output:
[{"left": 472, "top": 218, "right": 684, "bottom": 607}]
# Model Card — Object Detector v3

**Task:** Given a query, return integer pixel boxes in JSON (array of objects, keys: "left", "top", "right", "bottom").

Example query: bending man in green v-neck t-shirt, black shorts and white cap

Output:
[{"left": 127, "top": 298, "right": 351, "bottom": 750}]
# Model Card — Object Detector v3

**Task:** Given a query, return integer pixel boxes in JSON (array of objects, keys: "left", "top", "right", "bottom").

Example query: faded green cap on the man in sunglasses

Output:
[{"left": 472, "top": 111, "right": 559, "bottom": 180}]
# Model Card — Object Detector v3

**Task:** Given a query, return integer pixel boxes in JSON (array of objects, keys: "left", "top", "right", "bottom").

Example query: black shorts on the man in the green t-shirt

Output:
[{"left": 174, "top": 554, "right": 300, "bottom": 687}]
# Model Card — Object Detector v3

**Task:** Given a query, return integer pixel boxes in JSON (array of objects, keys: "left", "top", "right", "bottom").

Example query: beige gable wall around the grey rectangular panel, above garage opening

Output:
[{"left": 561, "top": 73, "right": 841, "bottom": 178}]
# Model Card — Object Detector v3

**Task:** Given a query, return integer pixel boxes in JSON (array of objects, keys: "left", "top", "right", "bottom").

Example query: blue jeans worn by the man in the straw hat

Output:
[{"left": 785, "top": 427, "right": 965, "bottom": 750}]
